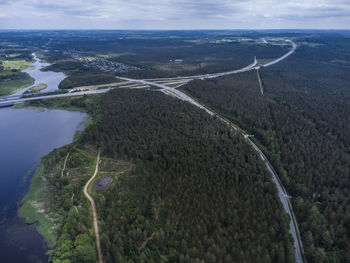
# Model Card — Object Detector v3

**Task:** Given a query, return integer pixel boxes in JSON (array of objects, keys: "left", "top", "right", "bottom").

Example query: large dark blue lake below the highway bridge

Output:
[{"left": 0, "top": 108, "right": 86, "bottom": 263}]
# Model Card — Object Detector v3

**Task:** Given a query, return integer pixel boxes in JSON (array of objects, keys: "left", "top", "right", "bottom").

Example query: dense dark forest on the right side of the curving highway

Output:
[{"left": 185, "top": 36, "right": 350, "bottom": 262}]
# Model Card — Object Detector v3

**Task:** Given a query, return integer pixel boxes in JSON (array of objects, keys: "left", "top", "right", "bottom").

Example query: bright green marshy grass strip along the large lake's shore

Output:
[{"left": 18, "top": 164, "right": 56, "bottom": 246}]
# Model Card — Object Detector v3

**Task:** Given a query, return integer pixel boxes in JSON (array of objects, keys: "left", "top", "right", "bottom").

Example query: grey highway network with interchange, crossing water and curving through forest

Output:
[{"left": 0, "top": 40, "right": 306, "bottom": 263}]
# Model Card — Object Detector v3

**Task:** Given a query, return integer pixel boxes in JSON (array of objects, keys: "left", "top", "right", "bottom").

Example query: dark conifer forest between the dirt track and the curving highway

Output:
[{"left": 78, "top": 90, "right": 294, "bottom": 263}]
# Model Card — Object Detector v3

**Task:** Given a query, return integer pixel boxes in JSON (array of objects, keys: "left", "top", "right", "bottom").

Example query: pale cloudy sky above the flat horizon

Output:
[{"left": 0, "top": 0, "right": 350, "bottom": 29}]
